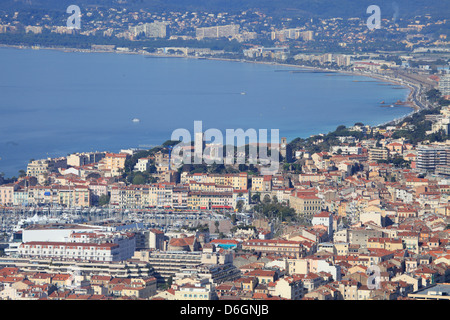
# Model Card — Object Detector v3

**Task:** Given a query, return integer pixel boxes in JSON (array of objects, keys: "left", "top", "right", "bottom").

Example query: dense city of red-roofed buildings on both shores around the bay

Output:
[{"left": 0, "top": 1, "right": 450, "bottom": 304}]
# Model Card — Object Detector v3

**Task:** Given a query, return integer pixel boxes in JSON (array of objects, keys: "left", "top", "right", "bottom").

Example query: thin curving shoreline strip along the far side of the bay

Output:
[{"left": 0, "top": 44, "right": 422, "bottom": 134}]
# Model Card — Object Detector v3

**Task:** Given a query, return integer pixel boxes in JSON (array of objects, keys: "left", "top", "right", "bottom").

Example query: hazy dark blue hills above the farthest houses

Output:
[{"left": 0, "top": 0, "right": 450, "bottom": 19}]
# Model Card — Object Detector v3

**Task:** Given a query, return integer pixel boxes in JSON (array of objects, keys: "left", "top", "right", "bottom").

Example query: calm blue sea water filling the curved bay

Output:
[{"left": 0, "top": 48, "right": 411, "bottom": 177}]
